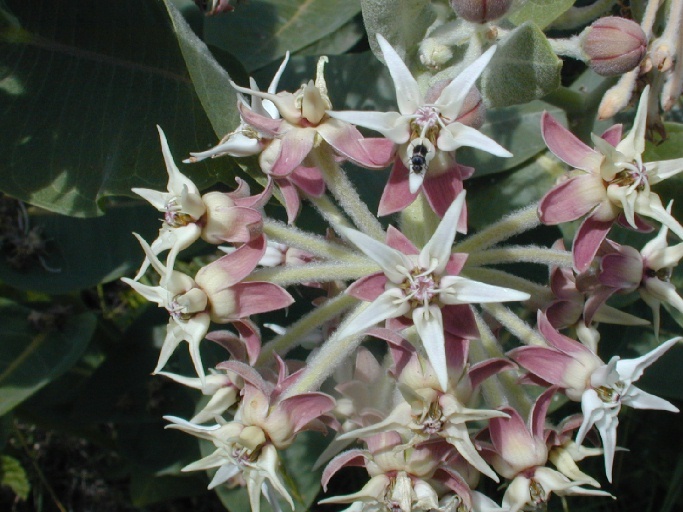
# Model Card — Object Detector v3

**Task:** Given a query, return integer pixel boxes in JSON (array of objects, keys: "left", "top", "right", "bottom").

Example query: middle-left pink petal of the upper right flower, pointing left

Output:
[{"left": 538, "top": 174, "right": 607, "bottom": 225}]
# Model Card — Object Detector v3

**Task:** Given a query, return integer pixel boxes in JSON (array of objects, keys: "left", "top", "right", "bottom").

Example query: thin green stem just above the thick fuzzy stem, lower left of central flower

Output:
[{"left": 256, "top": 293, "right": 358, "bottom": 366}]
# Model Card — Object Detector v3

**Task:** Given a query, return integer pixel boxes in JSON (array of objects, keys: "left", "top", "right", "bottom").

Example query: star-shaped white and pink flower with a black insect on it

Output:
[{"left": 328, "top": 34, "right": 512, "bottom": 218}]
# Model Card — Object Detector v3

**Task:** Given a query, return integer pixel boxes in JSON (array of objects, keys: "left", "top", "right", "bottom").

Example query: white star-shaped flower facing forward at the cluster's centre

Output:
[{"left": 337, "top": 191, "right": 529, "bottom": 390}]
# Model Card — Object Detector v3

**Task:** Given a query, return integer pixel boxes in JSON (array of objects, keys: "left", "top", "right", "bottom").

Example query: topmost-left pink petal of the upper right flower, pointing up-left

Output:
[{"left": 541, "top": 112, "right": 602, "bottom": 172}]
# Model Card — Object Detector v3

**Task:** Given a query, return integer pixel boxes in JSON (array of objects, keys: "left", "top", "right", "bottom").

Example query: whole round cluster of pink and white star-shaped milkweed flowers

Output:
[{"left": 124, "top": 4, "right": 683, "bottom": 512}]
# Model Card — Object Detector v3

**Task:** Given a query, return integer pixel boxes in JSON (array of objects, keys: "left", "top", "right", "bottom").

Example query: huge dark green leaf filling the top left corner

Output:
[{"left": 0, "top": 0, "right": 227, "bottom": 216}]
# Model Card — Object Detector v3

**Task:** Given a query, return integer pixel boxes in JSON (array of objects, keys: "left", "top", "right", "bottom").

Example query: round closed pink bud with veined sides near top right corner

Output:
[{"left": 581, "top": 16, "right": 647, "bottom": 76}]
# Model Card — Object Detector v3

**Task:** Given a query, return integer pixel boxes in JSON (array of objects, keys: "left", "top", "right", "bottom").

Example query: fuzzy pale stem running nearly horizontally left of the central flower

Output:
[{"left": 244, "top": 260, "right": 380, "bottom": 286}]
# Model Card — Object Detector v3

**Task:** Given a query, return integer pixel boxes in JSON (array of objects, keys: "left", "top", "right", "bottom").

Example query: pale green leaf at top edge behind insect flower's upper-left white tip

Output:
[{"left": 361, "top": 0, "right": 436, "bottom": 62}]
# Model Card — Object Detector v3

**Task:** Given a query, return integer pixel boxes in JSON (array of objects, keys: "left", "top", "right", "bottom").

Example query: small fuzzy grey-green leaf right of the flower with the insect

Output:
[{"left": 481, "top": 23, "right": 562, "bottom": 107}]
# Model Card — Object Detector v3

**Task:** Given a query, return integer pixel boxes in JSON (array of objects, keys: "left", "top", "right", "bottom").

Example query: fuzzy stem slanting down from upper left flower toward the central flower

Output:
[{"left": 312, "top": 146, "right": 385, "bottom": 241}]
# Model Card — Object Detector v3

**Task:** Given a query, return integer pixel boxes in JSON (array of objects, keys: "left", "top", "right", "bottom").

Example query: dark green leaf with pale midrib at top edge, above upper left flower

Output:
[{"left": 204, "top": 0, "right": 360, "bottom": 72}]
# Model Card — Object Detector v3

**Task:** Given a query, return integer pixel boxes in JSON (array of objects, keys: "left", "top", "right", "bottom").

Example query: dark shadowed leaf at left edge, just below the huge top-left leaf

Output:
[{"left": 0, "top": 201, "right": 161, "bottom": 294}]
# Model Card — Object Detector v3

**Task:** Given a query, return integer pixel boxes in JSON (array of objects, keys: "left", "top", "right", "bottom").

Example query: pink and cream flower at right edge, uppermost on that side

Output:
[{"left": 538, "top": 87, "right": 683, "bottom": 272}]
